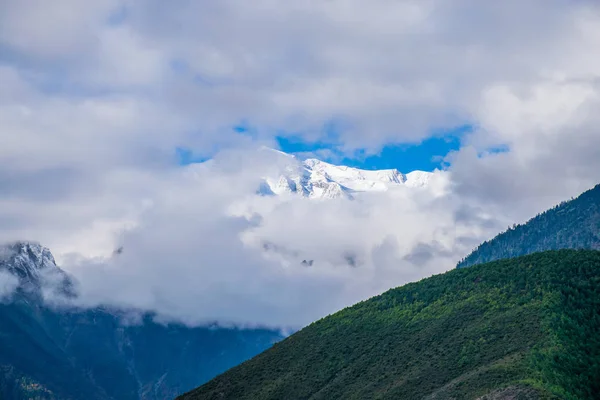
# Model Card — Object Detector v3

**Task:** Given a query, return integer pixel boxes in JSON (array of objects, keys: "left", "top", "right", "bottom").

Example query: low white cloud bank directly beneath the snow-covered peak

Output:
[{"left": 63, "top": 151, "right": 496, "bottom": 328}]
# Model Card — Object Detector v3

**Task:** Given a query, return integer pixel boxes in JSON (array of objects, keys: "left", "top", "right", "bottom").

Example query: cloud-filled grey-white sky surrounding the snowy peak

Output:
[{"left": 0, "top": 0, "right": 600, "bottom": 326}]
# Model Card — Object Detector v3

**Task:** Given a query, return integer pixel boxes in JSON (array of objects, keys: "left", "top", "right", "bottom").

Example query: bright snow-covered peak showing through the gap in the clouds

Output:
[{"left": 258, "top": 148, "right": 433, "bottom": 199}]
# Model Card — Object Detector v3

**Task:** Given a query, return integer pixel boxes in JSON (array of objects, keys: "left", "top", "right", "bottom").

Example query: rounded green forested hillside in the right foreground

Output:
[{"left": 180, "top": 250, "right": 600, "bottom": 400}]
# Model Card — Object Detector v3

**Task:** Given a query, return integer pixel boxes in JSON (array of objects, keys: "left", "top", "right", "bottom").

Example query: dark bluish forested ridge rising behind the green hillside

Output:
[{"left": 457, "top": 185, "right": 600, "bottom": 268}]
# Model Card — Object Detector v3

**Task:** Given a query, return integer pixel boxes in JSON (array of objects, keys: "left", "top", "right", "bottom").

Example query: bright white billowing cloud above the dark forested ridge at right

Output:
[{"left": 449, "top": 79, "right": 600, "bottom": 221}]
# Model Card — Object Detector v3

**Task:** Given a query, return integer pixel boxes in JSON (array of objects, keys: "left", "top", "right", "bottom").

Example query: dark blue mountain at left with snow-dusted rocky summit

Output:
[{"left": 0, "top": 243, "right": 281, "bottom": 400}]
